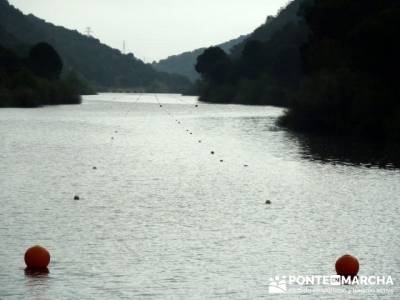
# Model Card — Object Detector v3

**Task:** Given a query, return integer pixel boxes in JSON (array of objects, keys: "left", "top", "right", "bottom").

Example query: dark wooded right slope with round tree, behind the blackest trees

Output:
[{"left": 196, "top": 0, "right": 309, "bottom": 106}]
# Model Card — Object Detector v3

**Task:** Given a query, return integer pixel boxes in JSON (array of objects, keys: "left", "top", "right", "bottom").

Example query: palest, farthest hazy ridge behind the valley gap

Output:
[{"left": 153, "top": 35, "right": 248, "bottom": 81}]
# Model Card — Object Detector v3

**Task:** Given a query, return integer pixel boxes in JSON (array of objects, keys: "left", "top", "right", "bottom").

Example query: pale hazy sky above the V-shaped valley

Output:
[{"left": 9, "top": 0, "right": 288, "bottom": 62}]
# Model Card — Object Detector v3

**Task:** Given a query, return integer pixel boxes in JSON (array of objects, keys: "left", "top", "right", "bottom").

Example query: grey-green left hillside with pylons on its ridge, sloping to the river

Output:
[{"left": 0, "top": 0, "right": 191, "bottom": 92}]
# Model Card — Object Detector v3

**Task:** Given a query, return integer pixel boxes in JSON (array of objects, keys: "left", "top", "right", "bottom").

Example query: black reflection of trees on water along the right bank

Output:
[{"left": 287, "top": 132, "right": 400, "bottom": 169}]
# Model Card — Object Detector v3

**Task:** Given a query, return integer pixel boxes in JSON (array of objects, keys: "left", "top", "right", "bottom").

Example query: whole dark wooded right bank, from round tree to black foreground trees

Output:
[{"left": 196, "top": 0, "right": 400, "bottom": 141}]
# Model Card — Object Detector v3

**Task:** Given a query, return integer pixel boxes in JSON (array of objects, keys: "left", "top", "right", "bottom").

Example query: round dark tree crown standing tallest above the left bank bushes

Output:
[{"left": 28, "top": 42, "right": 63, "bottom": 80}]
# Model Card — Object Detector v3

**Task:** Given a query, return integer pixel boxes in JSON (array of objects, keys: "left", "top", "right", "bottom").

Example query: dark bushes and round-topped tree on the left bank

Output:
[{"left": 0, "top": 43, "right": 84, "bottom": 107}]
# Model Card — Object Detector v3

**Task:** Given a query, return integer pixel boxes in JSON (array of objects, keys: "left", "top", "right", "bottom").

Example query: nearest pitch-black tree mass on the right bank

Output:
[{"left": 281, "top": 0, "right": 400, "bottom": 142}]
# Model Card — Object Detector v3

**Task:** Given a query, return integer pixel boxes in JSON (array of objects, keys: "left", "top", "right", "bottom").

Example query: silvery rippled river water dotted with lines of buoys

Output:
[{"left": 0, "top": 94, "right": 400, "bottom": 299}]
